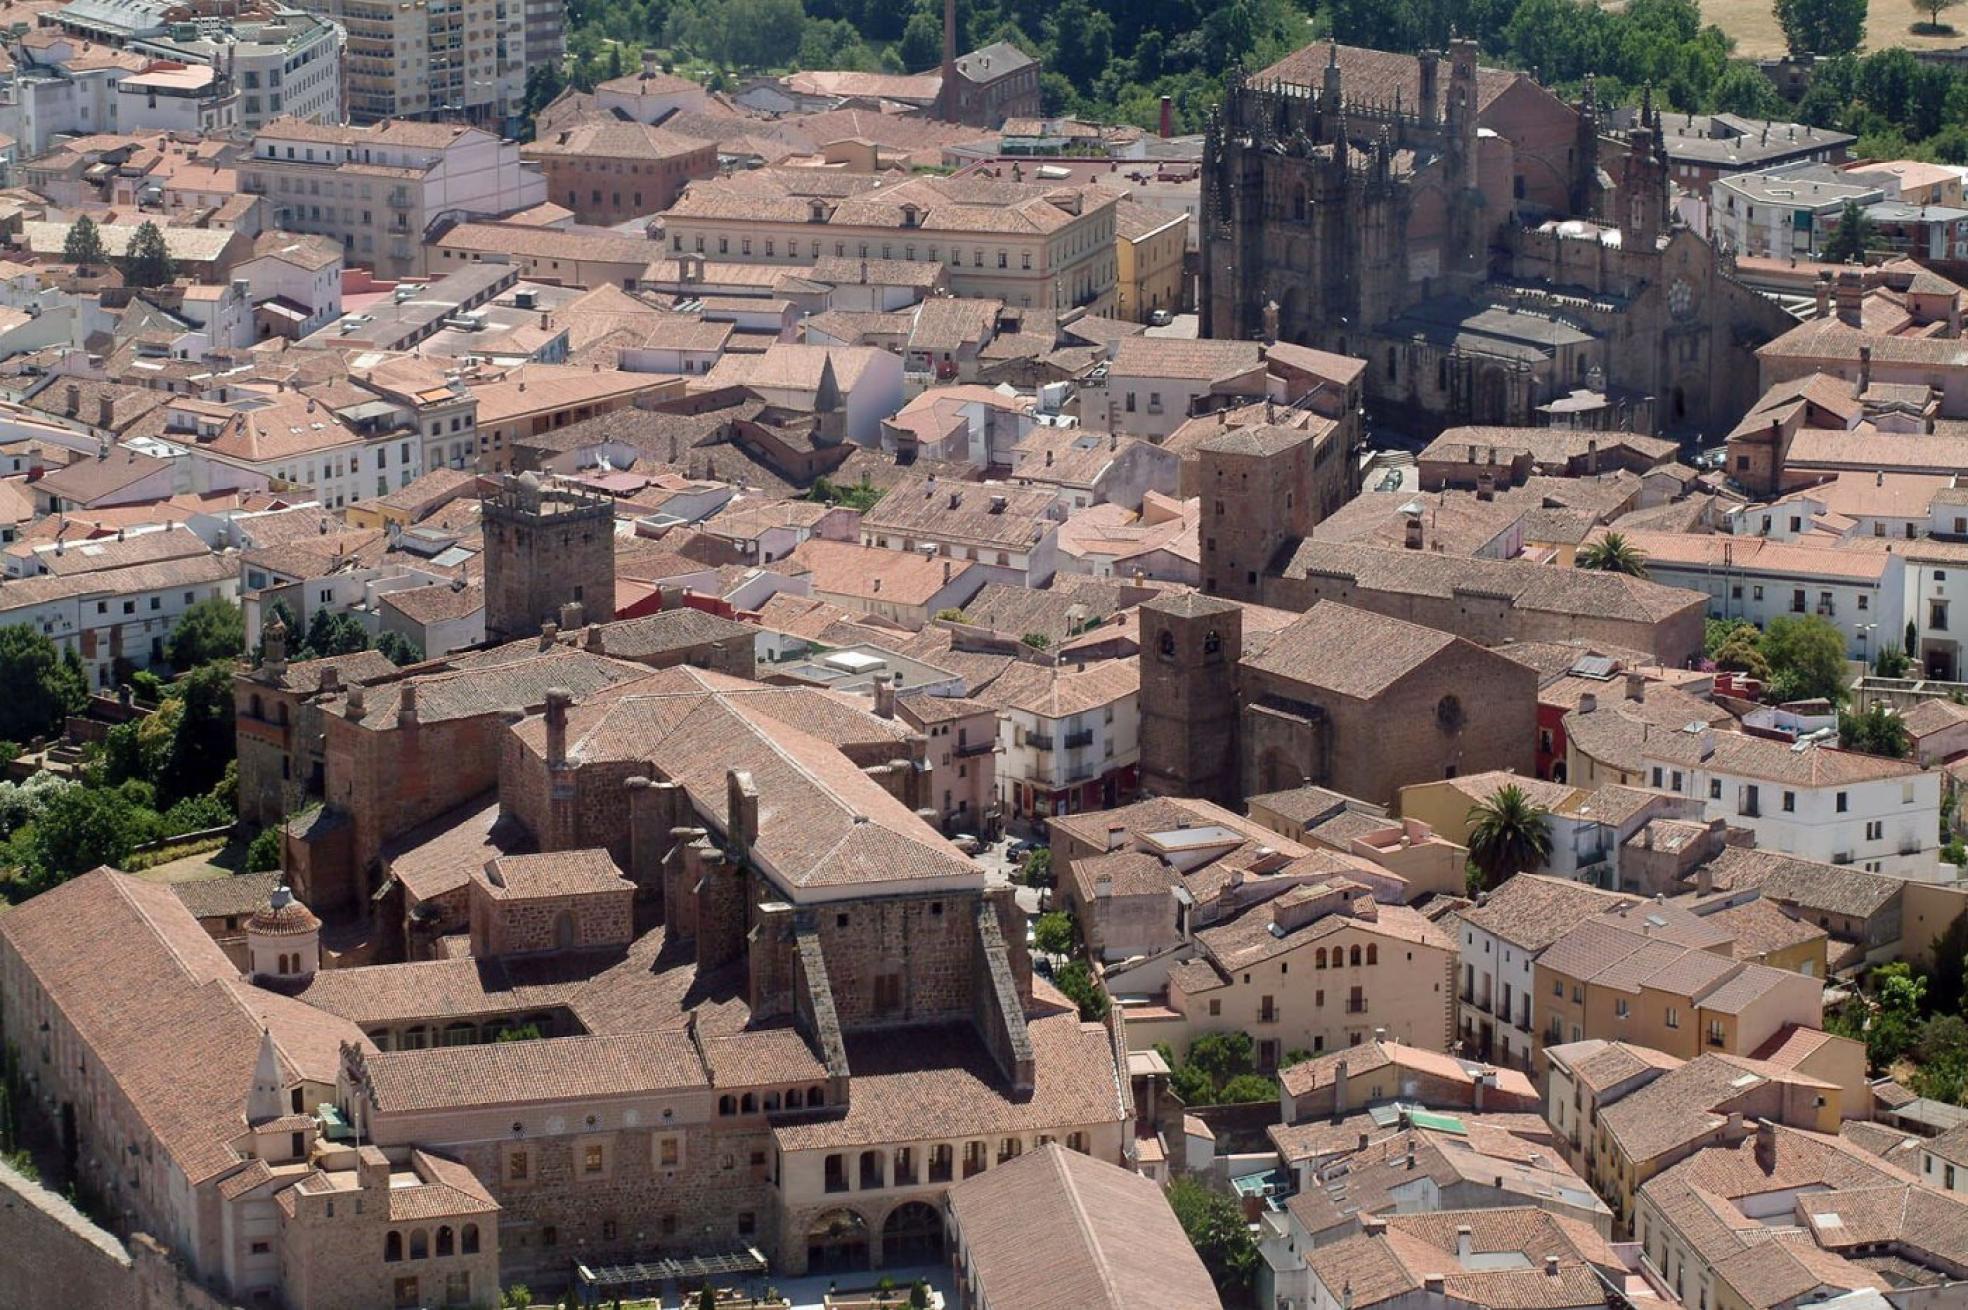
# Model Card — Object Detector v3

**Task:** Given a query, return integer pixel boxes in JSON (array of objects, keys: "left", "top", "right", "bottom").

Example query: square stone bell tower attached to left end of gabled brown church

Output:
[{"left": 1141, "top": 592, "right": 1244, "bottom": 804}]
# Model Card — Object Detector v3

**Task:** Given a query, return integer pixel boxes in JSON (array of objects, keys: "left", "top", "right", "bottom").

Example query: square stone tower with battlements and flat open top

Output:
[{"left": 482, "top": 474, "right": 614, "bottom": 641}]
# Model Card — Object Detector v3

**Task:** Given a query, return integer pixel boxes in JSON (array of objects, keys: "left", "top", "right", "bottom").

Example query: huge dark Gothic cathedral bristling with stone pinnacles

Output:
[{"left": 1200, "top": 39, "right": 1791, "bottom": 437}]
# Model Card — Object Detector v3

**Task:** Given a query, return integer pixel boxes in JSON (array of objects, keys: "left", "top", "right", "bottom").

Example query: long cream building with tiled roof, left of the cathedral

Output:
[{"left": 661, "top": 169, "right": 1118, "bottom": 315}]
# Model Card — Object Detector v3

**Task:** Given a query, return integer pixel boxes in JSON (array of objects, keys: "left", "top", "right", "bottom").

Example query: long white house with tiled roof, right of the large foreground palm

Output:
[{"left": 1641, "top": 726, "right": 1942, "bottom": 881}]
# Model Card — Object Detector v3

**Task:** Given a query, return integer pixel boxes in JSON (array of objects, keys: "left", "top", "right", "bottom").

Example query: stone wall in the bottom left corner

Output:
[{"left": 0, "top": 1162, "right": 230, "bottom": 1310}]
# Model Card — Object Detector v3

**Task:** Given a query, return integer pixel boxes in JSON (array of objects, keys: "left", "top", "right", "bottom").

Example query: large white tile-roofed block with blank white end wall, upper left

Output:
[{"left": 238, "top": 118, "right": 547, "bottom": 275}]
